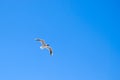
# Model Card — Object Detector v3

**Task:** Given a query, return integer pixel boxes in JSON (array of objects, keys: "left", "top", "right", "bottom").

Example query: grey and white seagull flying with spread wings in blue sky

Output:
[{"left": 35, "top": 38, "right": 53, "bottom": 56}]
